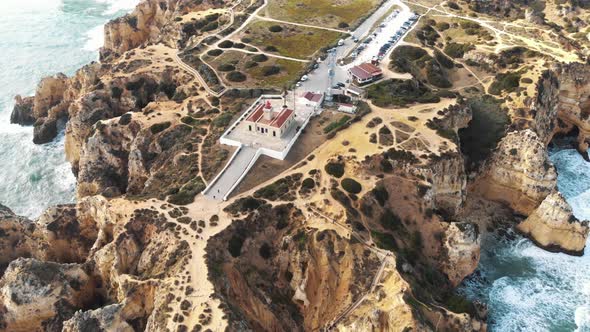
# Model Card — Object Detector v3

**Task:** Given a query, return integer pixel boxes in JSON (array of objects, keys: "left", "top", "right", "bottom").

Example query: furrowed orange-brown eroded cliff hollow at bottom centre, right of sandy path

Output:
[{"left": 207, "top": 205, "right": 380, "bottom": 331}]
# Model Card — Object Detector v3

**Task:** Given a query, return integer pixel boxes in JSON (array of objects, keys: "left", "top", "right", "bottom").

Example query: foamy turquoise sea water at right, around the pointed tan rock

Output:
[{"left": 459, "top": 149, "right": 590, "bottom": 332}]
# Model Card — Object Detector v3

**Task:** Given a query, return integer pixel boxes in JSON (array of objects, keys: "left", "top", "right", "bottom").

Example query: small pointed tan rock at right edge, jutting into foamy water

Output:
[{"left": 517, "top": 192, "right": 589, "bottom": 256}]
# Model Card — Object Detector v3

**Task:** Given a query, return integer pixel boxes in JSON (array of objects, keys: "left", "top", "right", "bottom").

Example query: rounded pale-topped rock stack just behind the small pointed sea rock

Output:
[{"left": 474, "top": 129, "right": 557, "bottom": 215}]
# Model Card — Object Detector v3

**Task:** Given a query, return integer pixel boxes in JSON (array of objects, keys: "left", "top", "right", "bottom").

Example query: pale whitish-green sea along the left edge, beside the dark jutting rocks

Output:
[{"left": 0, "top": 0, "right": 139, "bottom": 218}]
